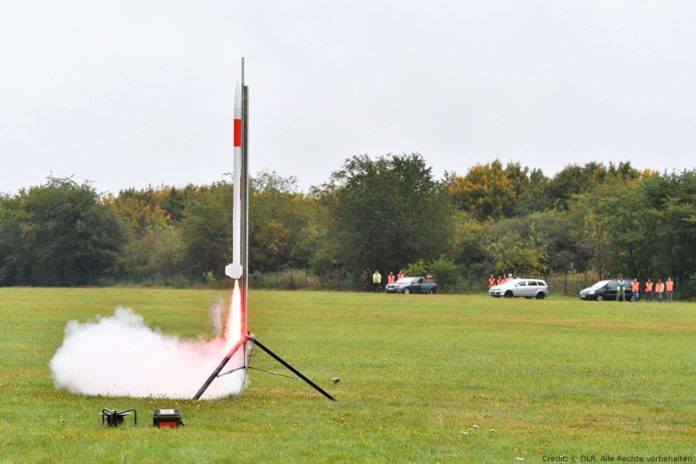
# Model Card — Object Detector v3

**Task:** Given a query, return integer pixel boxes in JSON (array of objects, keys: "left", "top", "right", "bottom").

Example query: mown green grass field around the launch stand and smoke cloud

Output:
[{"left": 0, "top": 288, "right": 696, "bottom": 463}]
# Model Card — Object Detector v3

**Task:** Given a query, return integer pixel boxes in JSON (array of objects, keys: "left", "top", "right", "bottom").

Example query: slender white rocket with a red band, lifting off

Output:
[{"left": 225, "top": 81, "right": 246, "bottom": 279}]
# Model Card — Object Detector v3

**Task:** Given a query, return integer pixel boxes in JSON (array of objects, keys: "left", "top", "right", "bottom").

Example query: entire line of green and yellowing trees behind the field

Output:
[{"left": 0, "top": 154, "right": 696, "bottom": 296}]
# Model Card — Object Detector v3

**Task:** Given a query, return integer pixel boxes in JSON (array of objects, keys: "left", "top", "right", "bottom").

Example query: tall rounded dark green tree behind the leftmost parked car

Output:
[{"left": 320, "top": 154, "right": 452, "bottom": 272}]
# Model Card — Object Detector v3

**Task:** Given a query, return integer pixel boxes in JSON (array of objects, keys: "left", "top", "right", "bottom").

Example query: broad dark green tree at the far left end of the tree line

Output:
[{"left": 0, "top": 177, "right": 125, "bottom": 285}]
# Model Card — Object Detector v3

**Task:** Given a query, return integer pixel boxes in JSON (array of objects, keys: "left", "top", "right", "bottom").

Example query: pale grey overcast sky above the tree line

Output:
[{"left": 0, "top": 0, "right": 696, "bottom": 192}]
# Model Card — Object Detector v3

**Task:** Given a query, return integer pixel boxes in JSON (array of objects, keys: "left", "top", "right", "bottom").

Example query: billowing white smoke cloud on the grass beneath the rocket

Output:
[{"left": 50, "top": 307, "right": 246, "bottom": 399}]
